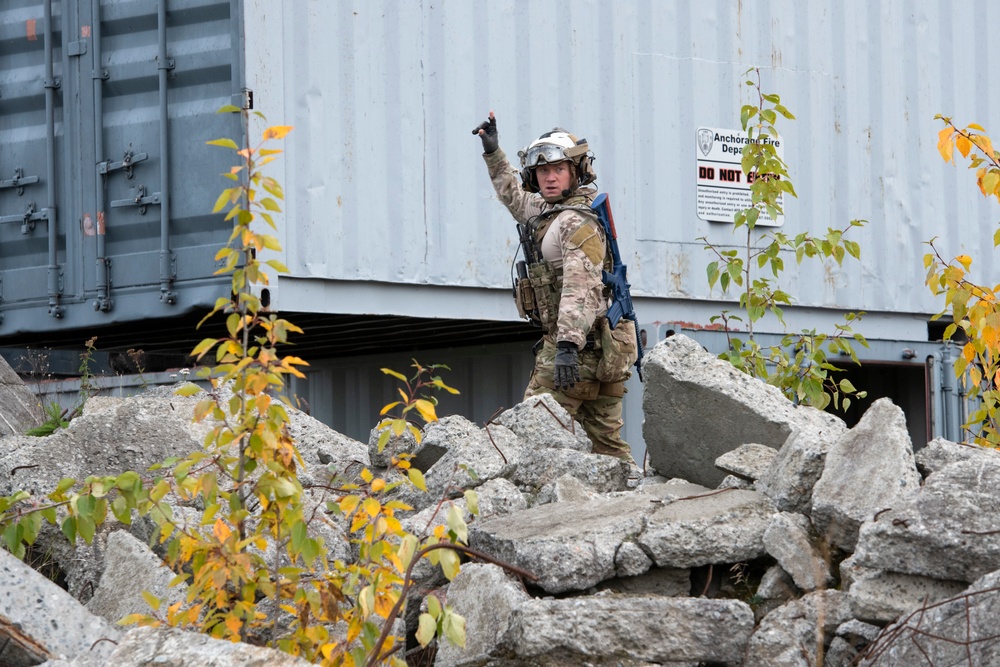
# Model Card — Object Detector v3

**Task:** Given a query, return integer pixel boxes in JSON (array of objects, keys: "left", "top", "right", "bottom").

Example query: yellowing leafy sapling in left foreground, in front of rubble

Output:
[{"left": 0, "top": 107, "right": 496, "bottom": 667}]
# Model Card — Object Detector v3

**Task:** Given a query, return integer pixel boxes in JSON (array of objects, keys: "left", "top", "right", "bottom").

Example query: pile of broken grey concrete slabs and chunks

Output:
[{"left": 0, "top": 335, "right": 1000, "bottom": 667}]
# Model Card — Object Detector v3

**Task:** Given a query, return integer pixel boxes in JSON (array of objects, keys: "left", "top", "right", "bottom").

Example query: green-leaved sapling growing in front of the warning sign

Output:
[{"left": 698, "top": 69, "right": 868, "bottom": 410}]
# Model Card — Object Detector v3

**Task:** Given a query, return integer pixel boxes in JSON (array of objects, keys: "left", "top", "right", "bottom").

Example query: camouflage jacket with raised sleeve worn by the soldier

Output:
[{"left": 483, "top": 149, "right": 608, "bottom": 348}]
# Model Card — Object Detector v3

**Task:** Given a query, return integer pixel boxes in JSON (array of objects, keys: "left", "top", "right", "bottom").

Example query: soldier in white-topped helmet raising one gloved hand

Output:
[{"left": 473, "top": 111, "right": 635, "bottom": 463}]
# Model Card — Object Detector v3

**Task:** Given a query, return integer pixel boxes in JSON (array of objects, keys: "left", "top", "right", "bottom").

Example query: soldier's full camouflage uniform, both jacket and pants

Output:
[{"left": 483, "top": 149, "right": 632, "bottom": 461}]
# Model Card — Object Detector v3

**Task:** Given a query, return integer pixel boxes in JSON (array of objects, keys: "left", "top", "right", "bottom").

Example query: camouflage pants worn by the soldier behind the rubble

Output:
[{"left": 524, "top": 337, "right": 632, "bottom": 461}]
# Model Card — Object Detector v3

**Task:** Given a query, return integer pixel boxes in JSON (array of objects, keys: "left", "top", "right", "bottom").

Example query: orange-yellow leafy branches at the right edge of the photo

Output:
[{"left": 924, "top": 115, "right": 1000, "bottom": 447}]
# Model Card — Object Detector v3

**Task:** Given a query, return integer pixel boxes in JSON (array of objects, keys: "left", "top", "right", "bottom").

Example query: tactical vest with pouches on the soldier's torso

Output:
[{"left": 514, "top": 195, "right": 611, "bottom": 335}]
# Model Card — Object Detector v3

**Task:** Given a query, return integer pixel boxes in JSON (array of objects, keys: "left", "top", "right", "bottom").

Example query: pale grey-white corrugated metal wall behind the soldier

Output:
[{"left": 247, "top": 0, "right": 1000, "bottom": 338}]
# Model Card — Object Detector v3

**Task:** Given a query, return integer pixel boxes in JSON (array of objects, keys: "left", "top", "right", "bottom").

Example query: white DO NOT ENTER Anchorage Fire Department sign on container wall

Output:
[{"left": 695, "top": 127, "right": 785, "bottom": 227}]
